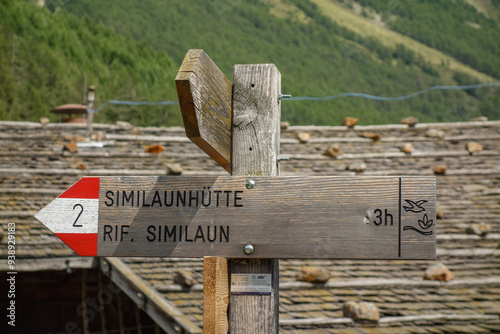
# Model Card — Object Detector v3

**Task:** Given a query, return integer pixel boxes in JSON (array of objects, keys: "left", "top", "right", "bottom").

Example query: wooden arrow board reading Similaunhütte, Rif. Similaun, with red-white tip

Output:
[{"left": 35, "top": 176, "right": 436, "bottom": 259}]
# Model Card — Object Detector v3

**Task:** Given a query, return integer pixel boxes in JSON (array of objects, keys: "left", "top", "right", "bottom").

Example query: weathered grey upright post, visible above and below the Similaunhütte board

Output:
[{"left": 229, "top": 64, "right": 281, "bottom": 334}]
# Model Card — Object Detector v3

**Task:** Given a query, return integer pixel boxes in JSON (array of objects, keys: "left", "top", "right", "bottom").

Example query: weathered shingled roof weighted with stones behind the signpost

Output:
[{"left": 0, "top": 121, "right": 500, "bottom": 333}]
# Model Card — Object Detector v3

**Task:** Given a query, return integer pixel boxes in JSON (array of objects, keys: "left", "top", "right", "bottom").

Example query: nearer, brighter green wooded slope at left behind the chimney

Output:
[{"left": 0, "top": 0, "right": 181, "bottom": 125}]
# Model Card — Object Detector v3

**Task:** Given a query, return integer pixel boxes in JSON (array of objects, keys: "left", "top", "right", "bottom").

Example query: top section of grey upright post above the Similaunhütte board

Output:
[{"left": 232, "top": 64, "right": 281, "bottom": 176}]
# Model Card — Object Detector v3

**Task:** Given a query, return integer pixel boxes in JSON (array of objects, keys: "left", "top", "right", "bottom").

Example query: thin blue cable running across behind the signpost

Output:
[{"left": 90, "top": 82, "right": 500, "bottom": 113}]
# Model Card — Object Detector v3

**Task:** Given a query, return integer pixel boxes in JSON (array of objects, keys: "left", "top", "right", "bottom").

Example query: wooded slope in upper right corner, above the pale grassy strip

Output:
[{"left": 336, "top": 0, "right": 500, "bottom": 78}]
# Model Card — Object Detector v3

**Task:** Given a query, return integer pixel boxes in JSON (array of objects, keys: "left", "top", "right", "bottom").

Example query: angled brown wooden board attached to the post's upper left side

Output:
[{"left": 175, "top": 49, "right": 232, "bottom": 172}]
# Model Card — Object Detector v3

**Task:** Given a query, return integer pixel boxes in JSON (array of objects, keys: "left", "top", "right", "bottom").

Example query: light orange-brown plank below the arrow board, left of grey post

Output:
[{"left": 203, "top": 256, "right": 229, "bottom": 334}]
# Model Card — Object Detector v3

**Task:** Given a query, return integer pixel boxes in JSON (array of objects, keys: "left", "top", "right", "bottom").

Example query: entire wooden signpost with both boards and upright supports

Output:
[{"left": 35, "top": 50, "right": 436, "bottom": 333}]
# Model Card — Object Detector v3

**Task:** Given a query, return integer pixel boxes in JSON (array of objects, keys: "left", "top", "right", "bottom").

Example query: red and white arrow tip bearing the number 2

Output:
[{"left": 35, "top": 177, "right": 99, "bottom": 256}]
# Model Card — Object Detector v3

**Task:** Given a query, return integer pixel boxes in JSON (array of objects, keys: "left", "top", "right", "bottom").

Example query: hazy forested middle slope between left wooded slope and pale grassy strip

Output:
[{"left": 52, "top": 0, "right": 500, "bottom": 124}]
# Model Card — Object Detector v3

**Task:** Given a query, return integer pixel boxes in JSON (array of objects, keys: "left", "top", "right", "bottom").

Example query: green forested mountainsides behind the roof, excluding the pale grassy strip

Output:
[{"left": 0, "top": 0, "right": 500, "bottom": 126}]
